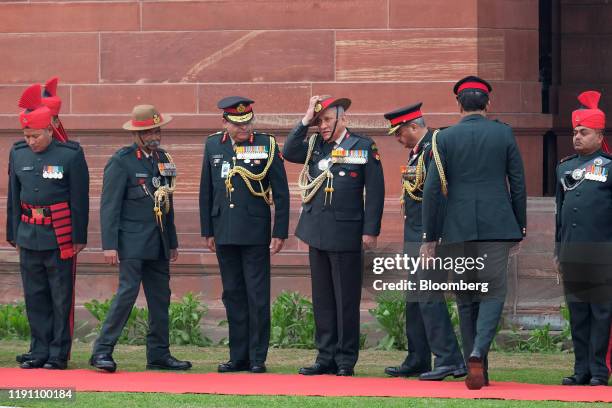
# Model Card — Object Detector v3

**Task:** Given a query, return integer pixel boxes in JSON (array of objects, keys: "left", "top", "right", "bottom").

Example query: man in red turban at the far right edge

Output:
[{"left": 555, "top": 91, "right": 612, "bottom": 385}]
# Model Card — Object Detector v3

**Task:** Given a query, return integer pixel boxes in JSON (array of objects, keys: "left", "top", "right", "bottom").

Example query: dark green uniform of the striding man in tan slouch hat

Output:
[{"left": 93, "top": 144, "right": 178, "bottom": 362}]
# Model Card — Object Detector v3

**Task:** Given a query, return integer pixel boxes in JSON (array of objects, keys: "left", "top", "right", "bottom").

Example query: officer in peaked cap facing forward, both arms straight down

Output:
[{"left": 200, "top": 96, "right": 289, "bottom": 373}]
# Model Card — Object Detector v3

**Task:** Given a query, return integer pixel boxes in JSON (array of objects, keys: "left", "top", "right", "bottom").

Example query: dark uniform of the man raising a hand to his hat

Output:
[{"left": 283, "top": 122, "right": 385, "bottom": 370}]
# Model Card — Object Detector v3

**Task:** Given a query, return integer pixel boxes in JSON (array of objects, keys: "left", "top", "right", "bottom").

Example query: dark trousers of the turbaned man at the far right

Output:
[{"left": 561, "top": 262, "right": 612, "bottom": 380}]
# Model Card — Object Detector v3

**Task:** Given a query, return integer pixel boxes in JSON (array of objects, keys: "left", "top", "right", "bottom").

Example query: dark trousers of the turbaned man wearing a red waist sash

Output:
[{"left": 19, "top": 247, "right": 74, "bottom": 360}]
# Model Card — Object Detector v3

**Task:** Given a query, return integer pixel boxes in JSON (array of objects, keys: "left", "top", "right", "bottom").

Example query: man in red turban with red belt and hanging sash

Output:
[{"left": 7, "top": 84, "right": 89, "bottom": 369}]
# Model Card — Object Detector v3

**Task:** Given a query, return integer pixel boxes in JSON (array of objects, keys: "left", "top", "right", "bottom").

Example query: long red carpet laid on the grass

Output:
[{"left": 0, "top": 368, "right": 612, "bottom": 402}]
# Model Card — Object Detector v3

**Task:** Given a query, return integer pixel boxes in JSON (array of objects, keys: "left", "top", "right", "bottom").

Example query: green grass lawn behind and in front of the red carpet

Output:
[{"left": 0, "top": 341, "right": 610, "bottom": 408}]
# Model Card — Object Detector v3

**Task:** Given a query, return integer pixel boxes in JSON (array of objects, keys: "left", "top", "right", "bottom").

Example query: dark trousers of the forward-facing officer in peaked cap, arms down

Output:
[{"left": 217, "top": 245, "right": 270, "bottom": 364}]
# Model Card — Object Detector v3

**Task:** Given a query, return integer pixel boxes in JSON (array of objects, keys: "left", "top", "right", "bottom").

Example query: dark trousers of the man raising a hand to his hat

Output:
[{"left": 309, "top": 247, "right": 363, "bottom": 368}]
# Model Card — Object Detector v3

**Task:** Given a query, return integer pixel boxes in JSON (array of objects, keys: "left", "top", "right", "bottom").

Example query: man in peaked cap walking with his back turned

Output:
[{"left": 421, "top": 76, "right": 527, "bottom": 389}]
